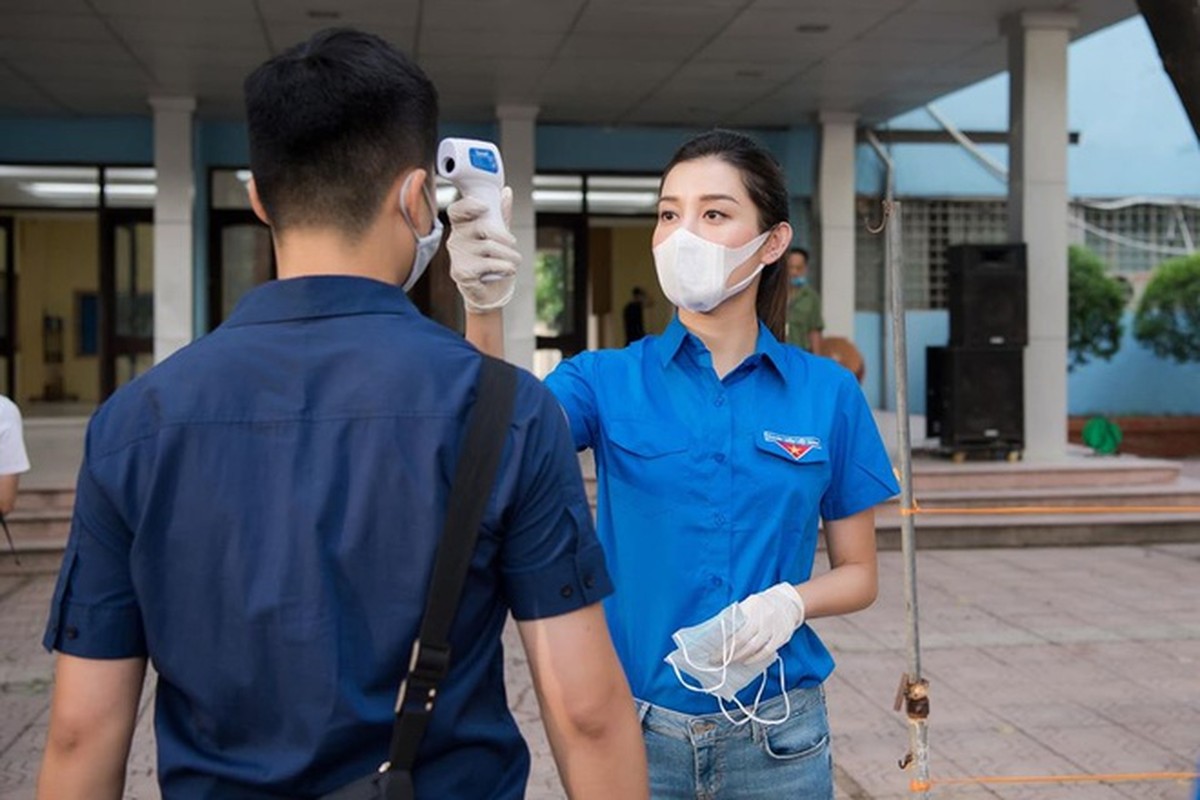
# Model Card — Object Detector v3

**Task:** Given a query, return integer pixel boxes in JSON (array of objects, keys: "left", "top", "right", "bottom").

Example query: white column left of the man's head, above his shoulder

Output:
[{"left": 150, "top": 97, "right": 196, "bottom": 362}]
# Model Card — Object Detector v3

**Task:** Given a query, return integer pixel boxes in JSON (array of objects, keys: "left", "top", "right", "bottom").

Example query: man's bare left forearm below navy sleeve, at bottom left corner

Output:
[{"left": 37, "top": 654, "right": 146, "bottom": 800}]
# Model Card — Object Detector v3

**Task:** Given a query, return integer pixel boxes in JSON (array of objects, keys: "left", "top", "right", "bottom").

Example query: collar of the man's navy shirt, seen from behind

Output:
[{"left": 224, "top": 275, "right": 416, "bottom": 326}]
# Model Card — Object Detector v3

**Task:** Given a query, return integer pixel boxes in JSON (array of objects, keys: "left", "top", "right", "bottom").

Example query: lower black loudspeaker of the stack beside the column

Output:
[{"left": 925, "top": 347, "right": 1025, "bottom": 450}]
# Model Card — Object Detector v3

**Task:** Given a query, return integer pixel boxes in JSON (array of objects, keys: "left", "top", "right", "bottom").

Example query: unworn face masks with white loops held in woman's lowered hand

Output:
[{"left": 664, "top": 603, "right": 792, "bottom": 726}]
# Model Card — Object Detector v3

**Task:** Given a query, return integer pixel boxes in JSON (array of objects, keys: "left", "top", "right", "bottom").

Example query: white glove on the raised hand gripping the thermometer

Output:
[{"left": 446, "top": 186, "right": 521, "bottom": 312}]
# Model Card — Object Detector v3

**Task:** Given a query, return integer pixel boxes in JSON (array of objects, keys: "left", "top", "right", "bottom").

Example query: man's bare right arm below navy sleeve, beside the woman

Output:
[{"left": 517, "top": 603, "right": 649, "bottom": 800}]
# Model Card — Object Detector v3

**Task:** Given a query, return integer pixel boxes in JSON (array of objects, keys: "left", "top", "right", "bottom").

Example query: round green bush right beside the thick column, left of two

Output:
[{"left": 1067, "top": 245, "right": 1126, "bottom": 369}]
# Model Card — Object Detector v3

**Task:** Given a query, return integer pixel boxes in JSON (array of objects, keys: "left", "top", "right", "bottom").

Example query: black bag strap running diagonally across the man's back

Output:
[{"left": 380, "top": 356, "right": 517, "bottom": 786}]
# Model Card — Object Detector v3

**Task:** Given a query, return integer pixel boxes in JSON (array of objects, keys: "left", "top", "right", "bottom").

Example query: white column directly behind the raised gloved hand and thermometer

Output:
[{"left": 496, "top": 106, "right": 538, "bottom": 369}]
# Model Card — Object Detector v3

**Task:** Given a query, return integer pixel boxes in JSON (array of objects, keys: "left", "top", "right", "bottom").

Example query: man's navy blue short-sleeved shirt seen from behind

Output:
[{"left": 44, "top": 277, "right": 611, "bottom": 799}]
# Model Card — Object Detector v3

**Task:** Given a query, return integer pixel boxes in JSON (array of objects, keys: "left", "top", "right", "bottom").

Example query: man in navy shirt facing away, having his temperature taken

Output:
[{"left": 38, "top": 25, "right": 647, "bottom": 800}]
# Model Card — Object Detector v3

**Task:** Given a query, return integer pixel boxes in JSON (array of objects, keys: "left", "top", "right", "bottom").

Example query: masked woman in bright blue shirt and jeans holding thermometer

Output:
[{"left": 451, "top": 131, "right": 898, "bottom": 799}]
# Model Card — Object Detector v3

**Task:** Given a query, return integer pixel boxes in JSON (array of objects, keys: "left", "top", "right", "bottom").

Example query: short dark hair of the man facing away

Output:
[{"left": 245, "top": 29, "right": 438, "bottom": 239}]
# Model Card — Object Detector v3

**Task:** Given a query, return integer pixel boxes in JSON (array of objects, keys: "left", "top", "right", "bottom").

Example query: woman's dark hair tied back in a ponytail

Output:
[{"left": 659, "top": 128, "right": 788, "bottom": 342}]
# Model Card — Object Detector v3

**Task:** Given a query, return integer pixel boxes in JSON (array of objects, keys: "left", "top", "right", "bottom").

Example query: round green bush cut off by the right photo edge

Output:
[{"left": 1133, "top": 253, "right": 1200, "bottom": 363}]
